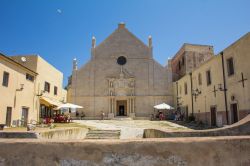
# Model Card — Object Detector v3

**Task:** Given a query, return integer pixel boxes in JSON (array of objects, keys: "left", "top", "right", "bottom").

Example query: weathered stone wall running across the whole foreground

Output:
[{"left": 0, "top": 136, "right": 250, "bottom": 166}]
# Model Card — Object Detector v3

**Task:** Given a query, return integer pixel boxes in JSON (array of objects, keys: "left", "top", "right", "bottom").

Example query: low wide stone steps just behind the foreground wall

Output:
[{"left": 85, "top": 130, "right": 121, "bottom": 139}]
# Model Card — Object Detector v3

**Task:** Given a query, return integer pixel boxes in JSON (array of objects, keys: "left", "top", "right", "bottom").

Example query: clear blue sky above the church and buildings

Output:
[{"left": 0, "top": 0, "right": 250, "bottom": 85}]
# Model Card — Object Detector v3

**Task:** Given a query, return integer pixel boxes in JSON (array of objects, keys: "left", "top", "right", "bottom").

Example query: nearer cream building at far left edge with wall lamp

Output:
[{"left": 0, "top": 54, "right": 38, "bottom": 126}]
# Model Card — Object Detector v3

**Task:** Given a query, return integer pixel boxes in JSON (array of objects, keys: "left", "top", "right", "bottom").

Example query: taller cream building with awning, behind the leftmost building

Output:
[{"left": 11, "top": 55, "right": 67, "bottom": 120}]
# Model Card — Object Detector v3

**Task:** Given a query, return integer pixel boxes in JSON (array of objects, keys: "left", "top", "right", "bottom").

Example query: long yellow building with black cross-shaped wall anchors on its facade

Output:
[{"left": 173, "top": 33, "right": 250, "bottom": 126}]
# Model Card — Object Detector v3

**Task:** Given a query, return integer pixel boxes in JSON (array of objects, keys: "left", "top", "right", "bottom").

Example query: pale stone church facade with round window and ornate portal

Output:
[{"left": 68, "top": 23, "right": 173, "bottom": 119}]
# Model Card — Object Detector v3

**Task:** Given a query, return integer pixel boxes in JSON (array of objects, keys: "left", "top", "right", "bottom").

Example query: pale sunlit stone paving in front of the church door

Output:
[{"left": 74, "top": 120, "right": 190, "bottom": 139}]
